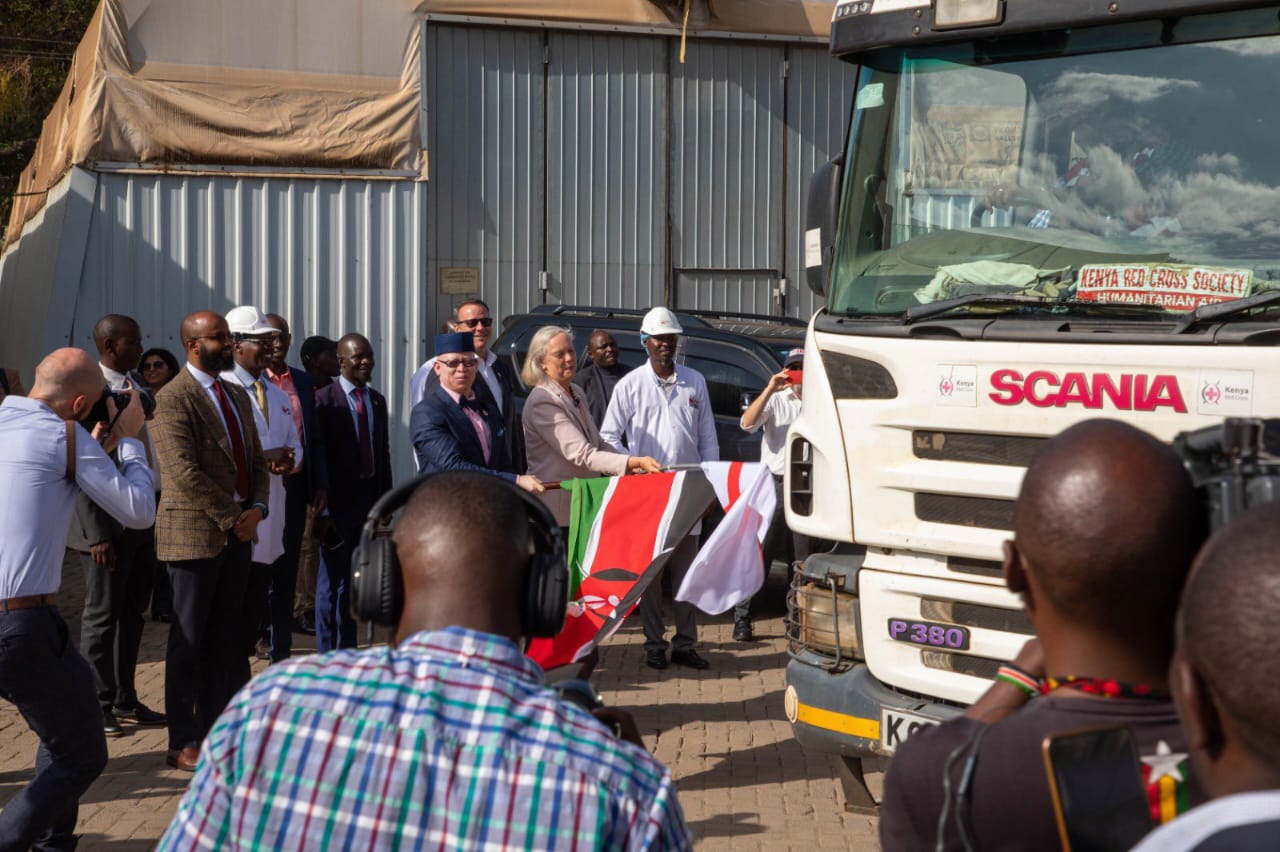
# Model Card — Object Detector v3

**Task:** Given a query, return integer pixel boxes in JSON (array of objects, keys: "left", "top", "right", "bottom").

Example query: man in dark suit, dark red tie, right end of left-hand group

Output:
[{"left": 315, "top": 334, "right": 392, "bottom": 651}]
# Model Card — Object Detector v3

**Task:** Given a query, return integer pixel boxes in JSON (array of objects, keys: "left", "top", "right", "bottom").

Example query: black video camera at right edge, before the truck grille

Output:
[{"left": 1174, "top": 417, "right": 1280, "bottom": 532}]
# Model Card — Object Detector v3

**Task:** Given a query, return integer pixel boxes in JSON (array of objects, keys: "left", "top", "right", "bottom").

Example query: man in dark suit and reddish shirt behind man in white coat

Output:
[{"left": 266, "top": 313, "right": 329, "bottom": 663}]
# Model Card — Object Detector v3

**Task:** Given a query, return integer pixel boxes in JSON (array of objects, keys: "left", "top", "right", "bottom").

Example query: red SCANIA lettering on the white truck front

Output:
[{"left": 989, "top": 368, "right": 1187, "bottom": 414}]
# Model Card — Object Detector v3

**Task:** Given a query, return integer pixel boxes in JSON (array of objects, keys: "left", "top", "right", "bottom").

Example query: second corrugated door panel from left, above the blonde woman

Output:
[{"left": 547, "top": 33, "right": 669, "bottom": 306}]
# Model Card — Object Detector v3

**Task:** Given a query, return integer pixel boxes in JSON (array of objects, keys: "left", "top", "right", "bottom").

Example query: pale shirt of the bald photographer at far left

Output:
[{"left": 0, "top": 395, "right": 156, "bottom": 593}]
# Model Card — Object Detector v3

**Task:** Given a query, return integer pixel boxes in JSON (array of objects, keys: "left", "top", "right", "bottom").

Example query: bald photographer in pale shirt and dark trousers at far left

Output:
[{"left": 0, "top": 348, "right": 156, "bottom": 849}]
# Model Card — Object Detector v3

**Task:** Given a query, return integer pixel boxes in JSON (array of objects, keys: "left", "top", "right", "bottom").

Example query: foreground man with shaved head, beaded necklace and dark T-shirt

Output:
[{"left": 879, "top": 420, "right": 1204, "bottom": 852}]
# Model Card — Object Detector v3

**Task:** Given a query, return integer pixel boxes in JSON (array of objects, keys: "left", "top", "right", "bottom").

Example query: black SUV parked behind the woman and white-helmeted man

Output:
[{"left": 490, "top": 304, "right": 805, "bottom": 462}]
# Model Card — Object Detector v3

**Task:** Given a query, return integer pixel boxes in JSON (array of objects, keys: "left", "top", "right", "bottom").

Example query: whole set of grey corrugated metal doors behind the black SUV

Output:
[{"left": 424, "top": 23, "right": 855, "bottom": 319}]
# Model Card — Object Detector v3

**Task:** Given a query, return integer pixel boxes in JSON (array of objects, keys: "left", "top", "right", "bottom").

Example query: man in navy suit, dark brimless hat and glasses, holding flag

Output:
[{"left": 408, "top": 331, "right": 545, "bottom": 494}]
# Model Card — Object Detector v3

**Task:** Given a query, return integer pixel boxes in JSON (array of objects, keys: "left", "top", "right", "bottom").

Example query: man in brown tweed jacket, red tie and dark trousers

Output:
[{"left": 151, "top": 311, "right": 270, "bottom": 771}]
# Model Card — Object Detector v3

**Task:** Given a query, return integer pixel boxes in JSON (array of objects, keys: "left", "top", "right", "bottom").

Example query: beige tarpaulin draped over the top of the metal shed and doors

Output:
[{"left": 5, "top": 0, "right": 832, "bottom": 248}]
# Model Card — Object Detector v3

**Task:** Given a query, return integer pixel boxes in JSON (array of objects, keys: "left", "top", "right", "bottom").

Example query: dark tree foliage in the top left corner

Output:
[{"left": 0, "top": 0, "right": 97, "bottom": 244}]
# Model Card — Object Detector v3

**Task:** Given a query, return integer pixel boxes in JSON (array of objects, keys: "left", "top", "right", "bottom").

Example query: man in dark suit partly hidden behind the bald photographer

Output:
[{"left": 67, "top": 313, "right": 165, "bottom": 737}]
